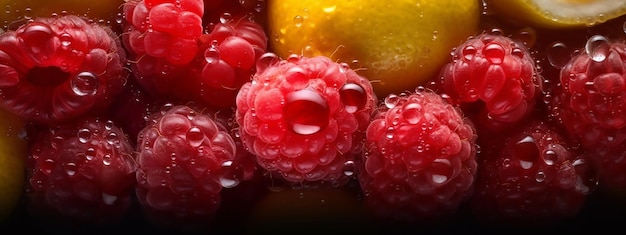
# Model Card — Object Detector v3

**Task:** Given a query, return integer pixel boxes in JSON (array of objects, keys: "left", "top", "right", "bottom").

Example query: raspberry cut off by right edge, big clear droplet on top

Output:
[{"left": 549, "top": 35, "right": 626, "bottom": 198}]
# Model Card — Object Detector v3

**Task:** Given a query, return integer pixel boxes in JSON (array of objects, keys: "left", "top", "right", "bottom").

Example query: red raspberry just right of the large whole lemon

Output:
[{"left": 433, "top": 33, "right": 542, "bottom": 132}]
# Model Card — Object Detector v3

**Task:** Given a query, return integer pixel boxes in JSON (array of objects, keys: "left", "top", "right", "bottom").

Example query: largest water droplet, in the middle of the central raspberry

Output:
[{"left": 283, "top": 89, "right": 330, "bottom": 135}]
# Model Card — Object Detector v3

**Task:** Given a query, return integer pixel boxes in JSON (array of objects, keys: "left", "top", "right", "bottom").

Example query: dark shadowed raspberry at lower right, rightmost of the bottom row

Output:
[{"left": 470, "top": 120, "right": 597, "bottom": 227}]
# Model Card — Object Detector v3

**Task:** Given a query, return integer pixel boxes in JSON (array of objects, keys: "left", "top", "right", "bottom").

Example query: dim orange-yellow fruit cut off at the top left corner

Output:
[{"left": 0, "top": 0, "right": 124, "bottom": 26}]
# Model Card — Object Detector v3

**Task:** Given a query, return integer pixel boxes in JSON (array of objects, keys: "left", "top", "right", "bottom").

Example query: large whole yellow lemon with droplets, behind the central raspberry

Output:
[{"left": 267, "top": 0, "right": 481, "bottom": 97}]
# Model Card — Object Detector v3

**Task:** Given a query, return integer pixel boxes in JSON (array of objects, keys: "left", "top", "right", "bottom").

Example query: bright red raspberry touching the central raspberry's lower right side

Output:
[{"left": 358, "top": 88, "right": 477, "bottom": 223}]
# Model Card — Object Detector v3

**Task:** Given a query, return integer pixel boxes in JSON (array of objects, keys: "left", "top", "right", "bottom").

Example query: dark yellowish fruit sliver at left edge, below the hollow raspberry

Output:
[{"left": 0, "top": 109, "right": 27, "bottom": 224}]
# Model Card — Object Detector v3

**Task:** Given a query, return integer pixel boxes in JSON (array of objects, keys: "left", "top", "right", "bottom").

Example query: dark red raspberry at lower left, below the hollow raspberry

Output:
[{"left": 26, "top": 117, "right": 136, "bottom": 225}]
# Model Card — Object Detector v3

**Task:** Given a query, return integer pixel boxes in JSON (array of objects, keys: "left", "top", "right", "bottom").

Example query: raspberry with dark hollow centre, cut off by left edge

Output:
[{"left": 0, "top": 15, "right": 126, "bottom": 123}]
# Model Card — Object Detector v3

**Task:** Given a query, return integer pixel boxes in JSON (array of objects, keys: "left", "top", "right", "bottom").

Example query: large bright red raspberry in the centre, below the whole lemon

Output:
[{"left": 235, "top": 54, "right": 377, "bottom": 186}]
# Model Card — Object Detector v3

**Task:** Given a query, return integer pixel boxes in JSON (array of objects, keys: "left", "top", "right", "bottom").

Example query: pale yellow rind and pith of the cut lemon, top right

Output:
[{"left": 486, "top": 0, "right": 626, "bottom": 29}]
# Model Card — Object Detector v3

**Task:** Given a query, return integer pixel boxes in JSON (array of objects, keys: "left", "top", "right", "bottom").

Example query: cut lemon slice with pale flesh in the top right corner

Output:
[{"left": 486, "top": 0, "right": 626, "bottom": 28}]
